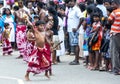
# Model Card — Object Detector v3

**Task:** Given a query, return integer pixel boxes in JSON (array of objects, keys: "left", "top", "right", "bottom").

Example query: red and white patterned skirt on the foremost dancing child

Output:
[{"left": 27, "top": 44, "right": 51, "bottom": 74}]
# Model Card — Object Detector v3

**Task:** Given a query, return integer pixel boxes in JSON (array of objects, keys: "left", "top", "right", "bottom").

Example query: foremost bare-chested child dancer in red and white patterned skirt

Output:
[{"left": 25, "top": 21, "right": 51, "bottom": 81}]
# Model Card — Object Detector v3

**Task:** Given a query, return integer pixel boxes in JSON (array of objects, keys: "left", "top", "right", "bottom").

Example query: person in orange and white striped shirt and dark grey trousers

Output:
[{"left": 108, "top": 0, "right": 120, "bottom": 75}]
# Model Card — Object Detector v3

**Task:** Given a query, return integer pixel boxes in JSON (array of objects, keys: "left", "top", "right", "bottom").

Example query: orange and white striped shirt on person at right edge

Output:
[{"left": 108, "top": 8, "right": 120, "bottom": 33}]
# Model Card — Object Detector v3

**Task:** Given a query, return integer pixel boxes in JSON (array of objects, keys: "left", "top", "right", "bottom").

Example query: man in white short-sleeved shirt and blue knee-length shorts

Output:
[{"left": 67, "top": 0, "right": 83, "bottom": 65}]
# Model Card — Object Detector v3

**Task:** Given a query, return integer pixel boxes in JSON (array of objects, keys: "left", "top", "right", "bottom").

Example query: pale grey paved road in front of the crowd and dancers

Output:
[{"left": 0, "top": 49, "right": 120, "bottom": 84}]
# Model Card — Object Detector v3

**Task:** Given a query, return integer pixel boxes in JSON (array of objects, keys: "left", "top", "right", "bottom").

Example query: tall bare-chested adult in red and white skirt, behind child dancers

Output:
[{"left": 15, "top": 0, "right": 28, "bottom": 58}]
